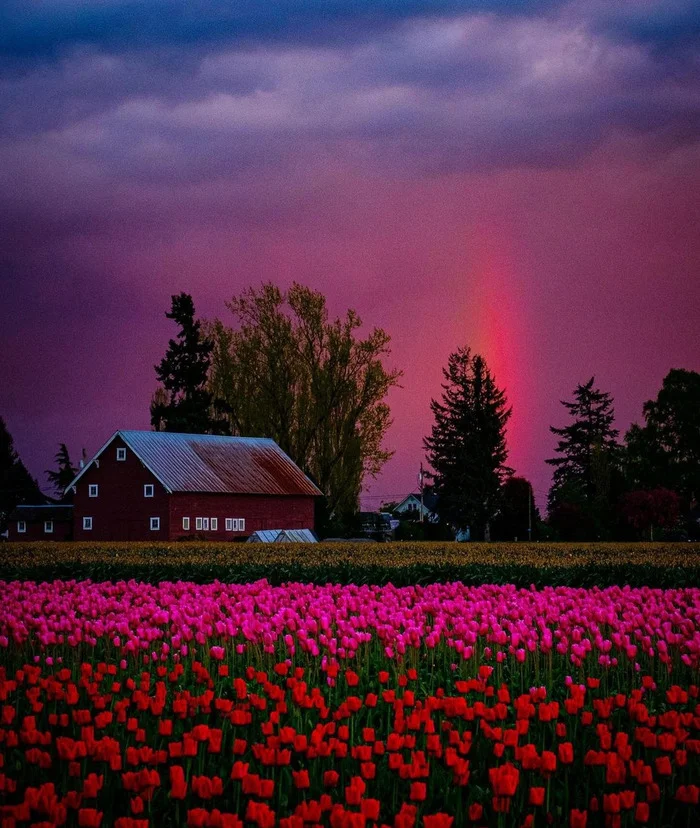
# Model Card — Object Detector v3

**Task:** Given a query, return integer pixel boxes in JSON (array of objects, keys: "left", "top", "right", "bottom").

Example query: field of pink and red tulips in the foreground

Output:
[{"left": 0, "top": 579, "right": 700, "bottom": 828}]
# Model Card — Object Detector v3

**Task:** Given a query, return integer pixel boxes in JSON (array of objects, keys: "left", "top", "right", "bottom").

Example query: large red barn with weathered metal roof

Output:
[{"left": 69, "top": 431, "right": 321, "bottom": 541}]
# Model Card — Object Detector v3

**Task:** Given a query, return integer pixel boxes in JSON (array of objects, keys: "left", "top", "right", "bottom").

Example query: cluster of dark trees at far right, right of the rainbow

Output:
[{"left": 547, "top": 369, "right": 700, "bottom": 540}]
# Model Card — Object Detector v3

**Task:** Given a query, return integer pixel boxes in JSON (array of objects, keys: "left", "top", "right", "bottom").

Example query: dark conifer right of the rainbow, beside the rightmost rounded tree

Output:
[{"left": 547, "top": 377, "right": 620, "bottom": 540}]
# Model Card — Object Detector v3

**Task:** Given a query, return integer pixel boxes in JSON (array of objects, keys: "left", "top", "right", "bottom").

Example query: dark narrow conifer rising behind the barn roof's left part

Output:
[{"left": 151, "top": 293, "right": 227, "bottom": 434}]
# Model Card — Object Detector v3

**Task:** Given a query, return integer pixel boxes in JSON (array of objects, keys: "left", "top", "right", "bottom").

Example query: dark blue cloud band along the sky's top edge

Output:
[{"left": 0, "top": 0, "right": 700, "bottom": 72}]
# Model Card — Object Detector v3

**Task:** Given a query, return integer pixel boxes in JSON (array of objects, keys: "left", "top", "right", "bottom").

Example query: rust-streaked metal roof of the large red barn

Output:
[{"left": 68, "top": 431, "right": 321, "bottom": 496}]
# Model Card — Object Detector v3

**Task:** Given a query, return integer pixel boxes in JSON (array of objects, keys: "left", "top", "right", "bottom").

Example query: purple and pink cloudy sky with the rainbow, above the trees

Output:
[{"left": 0, "top": 0, "right": 700, "bottom": 508}]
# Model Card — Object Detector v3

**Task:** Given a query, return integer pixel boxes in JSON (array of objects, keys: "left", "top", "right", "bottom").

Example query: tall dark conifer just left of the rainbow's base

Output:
[{"left": 424, "top": 348, "right": 512, "bottom": 537}]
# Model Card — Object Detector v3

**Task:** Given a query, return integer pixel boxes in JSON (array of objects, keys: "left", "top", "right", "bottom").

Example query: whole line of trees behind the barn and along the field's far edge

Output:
[{"left": 0, "top": 283, "right": 700, "bottom": 541}]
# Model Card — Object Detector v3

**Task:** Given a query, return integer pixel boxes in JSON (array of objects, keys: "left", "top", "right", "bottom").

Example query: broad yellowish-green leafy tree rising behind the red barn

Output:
[{"left": 209, "top": 283, "right": 401, "bottom": 518}]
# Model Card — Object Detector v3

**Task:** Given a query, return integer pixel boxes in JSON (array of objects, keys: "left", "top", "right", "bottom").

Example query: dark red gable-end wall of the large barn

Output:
[{"left": 73, "top": 437, "right": 169, "bottom": 541}]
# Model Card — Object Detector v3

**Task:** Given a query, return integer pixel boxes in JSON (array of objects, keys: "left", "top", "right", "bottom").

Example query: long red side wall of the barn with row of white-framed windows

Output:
[{"left": 170, "top": 493, "right": 314, "bottom": 541}]
